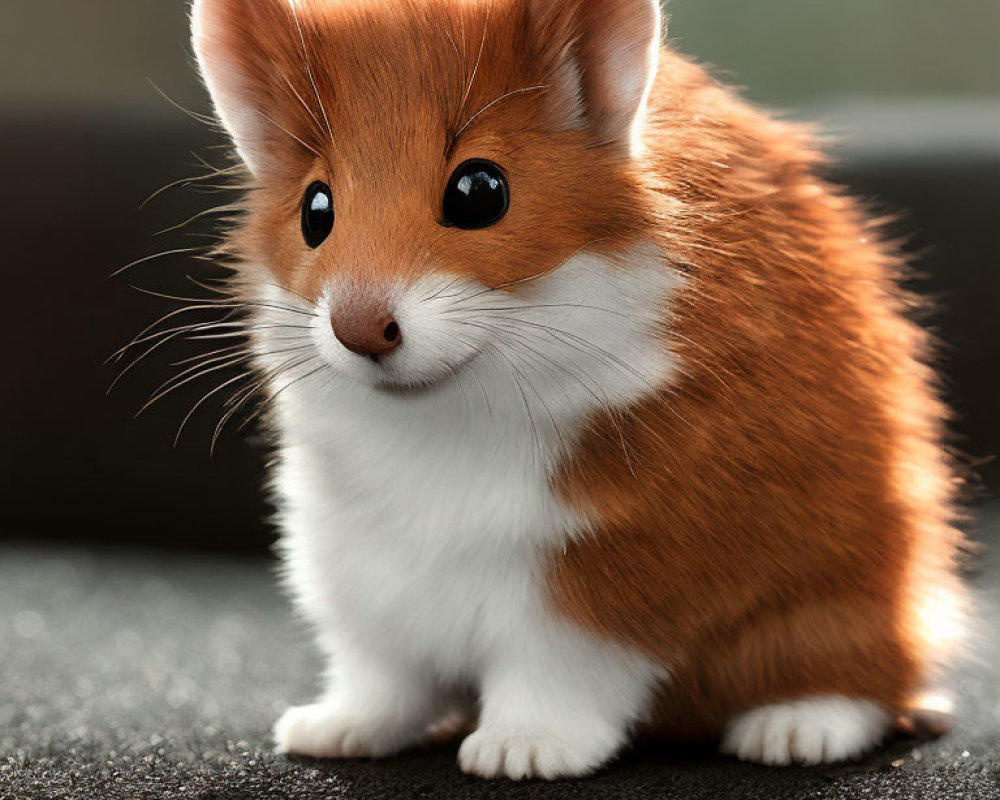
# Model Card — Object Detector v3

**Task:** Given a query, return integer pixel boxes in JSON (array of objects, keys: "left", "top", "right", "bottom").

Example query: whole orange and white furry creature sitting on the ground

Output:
[{"left": 193, "top": 0, "right": 961, "bottom": 778}]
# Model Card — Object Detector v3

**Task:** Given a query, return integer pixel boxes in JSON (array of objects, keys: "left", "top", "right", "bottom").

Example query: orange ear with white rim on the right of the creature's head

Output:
[{"left": 531, "top": 0, "right": 662, "bottom": 154}]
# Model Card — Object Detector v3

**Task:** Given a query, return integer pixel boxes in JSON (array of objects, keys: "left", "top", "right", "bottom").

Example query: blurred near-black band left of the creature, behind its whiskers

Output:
[{"left": 0, "top": 110, "right": 270, "bottom": 552}]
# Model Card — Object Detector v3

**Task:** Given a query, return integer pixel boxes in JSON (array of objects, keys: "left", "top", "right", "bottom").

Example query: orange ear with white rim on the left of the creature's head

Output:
[{"left": 191, "top": 0, "right": 298, "bottom": 176}]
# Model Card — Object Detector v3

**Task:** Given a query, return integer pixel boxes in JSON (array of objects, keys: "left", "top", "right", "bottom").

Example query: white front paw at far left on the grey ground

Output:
[{"left": 274, "top": 703, "right": 420, "bottom": 758}]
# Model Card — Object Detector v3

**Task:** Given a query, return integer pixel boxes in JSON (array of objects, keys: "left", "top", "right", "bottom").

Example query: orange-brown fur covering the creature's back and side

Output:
[{"left": 551, "top": 52, "right": 960, "bottom": 736}]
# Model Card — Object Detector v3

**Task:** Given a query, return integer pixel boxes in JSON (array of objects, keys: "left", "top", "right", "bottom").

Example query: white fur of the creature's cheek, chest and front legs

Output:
[{"left": 261, "top": 250, "right": 678, "bottom": 772}]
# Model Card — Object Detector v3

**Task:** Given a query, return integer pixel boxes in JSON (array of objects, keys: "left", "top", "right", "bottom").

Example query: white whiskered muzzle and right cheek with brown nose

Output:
[{"left": 262, "top": 244, "right": 683, "bottom": 412}]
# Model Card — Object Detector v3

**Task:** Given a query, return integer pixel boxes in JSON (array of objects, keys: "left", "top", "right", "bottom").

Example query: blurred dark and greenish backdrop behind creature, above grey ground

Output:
[{"left": 0, "top": 0, "right": 1000, "bottom": 552}]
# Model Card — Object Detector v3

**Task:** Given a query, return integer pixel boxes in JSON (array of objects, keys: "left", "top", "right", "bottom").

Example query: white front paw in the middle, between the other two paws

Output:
[{"left": 458, "top": 727, "right": 617, "bottom": 780}]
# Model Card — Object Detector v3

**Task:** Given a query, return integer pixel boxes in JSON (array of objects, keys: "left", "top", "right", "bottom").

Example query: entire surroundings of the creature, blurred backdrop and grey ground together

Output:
[{"left": 0, "top": 6, "right": 1000, "bottom": 800}]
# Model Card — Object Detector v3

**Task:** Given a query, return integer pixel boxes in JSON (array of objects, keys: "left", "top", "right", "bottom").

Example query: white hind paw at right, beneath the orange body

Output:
[{"left": 721, "top": 695, "right": 892, "bottom": 766}]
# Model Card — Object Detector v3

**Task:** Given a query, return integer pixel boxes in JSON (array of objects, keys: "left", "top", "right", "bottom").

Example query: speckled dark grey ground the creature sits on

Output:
[{"left": 0, "top": 507, "right": 1000, "bottom": 800}]
